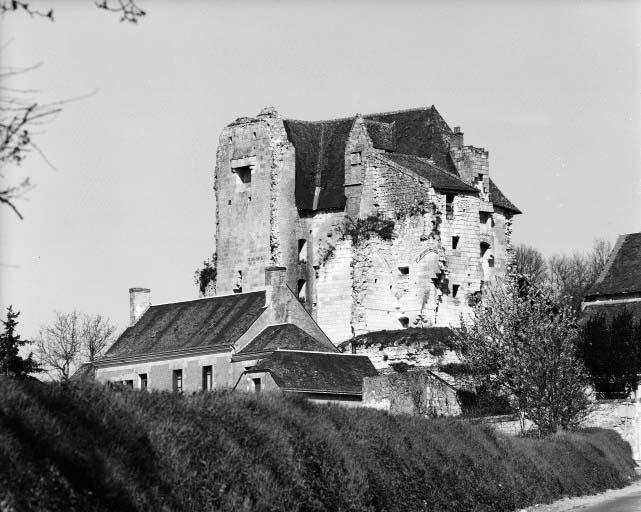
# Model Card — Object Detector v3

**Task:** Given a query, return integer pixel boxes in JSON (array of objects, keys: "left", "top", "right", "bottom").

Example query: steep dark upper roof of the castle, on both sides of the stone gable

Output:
[{"left": 283, "top": 107, "right": 455, "bottom": 210}]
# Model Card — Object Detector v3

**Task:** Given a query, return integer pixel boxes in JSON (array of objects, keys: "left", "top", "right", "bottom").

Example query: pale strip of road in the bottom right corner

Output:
[{"left": 519, "top": 480, "right": 641, "bottom": 512}]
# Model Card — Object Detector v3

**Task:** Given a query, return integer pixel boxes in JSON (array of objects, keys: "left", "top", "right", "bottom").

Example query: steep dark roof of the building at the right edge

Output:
[{"left": 586, "top": 233, "right": 641, "bottom": 297}]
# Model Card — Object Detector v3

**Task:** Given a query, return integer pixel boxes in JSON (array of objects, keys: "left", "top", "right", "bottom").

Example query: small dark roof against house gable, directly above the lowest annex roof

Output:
[{"left": 236, "top": 324, "right": 337, "bottom": 356}]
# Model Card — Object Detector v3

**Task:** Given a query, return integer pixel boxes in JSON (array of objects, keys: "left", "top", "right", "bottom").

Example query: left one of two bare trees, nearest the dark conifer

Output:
[{"left": 36, "top": 311, "right": 82, "bottom": 380}]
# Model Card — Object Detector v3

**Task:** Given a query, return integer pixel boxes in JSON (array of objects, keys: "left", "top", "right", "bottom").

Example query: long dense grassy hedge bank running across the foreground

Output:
[{"left": 0, "top": 379, "right": 634, "bottom": 511}]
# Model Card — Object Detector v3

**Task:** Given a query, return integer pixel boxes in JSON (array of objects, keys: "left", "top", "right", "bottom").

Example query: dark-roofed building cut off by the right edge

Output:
[{"left": 582, "top": 233, "right": 641, "bottom": 323}]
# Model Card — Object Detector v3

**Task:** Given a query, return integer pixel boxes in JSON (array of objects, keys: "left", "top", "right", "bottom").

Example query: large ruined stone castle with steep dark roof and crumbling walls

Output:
[{"left": 208, "top": 106, "right": 520, "bottom": 344}]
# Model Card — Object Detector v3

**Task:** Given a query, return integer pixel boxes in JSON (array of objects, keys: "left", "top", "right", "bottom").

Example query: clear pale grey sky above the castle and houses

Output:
[{"left": 0, "top": 0, "right": 641, "bottom": 337}]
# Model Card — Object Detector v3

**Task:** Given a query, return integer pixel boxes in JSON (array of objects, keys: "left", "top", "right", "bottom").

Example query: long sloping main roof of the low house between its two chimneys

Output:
[{"left": 105, "top": 291, "right": 265, "bottom": 358}]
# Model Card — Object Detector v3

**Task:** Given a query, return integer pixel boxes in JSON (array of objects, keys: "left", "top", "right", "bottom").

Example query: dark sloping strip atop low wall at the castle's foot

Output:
[{"left": 339, "top": 327, "right": 454, "bottom": 350}]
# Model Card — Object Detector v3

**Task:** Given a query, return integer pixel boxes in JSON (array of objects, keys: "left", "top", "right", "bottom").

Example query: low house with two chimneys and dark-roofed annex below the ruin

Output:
[{"left": 94, "top": 267, "right": 377, "bottom": 402}]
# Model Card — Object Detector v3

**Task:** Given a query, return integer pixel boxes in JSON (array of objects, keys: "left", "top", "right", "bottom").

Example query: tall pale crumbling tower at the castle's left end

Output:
[{"left": 214, "top": 109, "right": 297, "bottom": 294}]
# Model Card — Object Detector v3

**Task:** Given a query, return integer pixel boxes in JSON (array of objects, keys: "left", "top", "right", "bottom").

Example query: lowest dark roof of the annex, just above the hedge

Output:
[{"left": 248, "top": 350, "right": 378, "bottom": 395}]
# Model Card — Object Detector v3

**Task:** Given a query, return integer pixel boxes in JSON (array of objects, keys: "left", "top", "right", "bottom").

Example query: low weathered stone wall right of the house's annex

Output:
[{"left": 363, "top": 369, "right": 461, "bottom": 416}]
